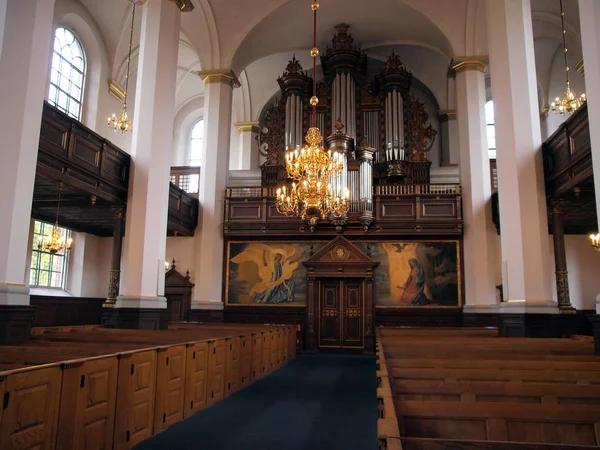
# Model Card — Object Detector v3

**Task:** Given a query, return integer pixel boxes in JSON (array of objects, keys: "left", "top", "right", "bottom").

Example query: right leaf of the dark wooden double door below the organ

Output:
[{"left": 341, "top": 280, "right": 364, "bottom": 347}]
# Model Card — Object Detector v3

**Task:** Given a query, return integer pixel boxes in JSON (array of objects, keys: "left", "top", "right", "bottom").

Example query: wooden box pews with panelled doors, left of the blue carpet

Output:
[{"left": 0, "top": 325, "right": 296, "bottom": 450}]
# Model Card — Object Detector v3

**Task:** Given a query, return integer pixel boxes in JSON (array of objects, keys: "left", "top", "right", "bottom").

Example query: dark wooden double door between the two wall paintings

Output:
[{"left": 318, "top": 278, "right": 364, "bottom": 349}]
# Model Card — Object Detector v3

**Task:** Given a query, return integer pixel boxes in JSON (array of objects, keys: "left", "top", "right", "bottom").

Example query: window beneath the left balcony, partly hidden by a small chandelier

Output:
[{"left": 29, "top": 220, "right": 71, "bottom": 289}]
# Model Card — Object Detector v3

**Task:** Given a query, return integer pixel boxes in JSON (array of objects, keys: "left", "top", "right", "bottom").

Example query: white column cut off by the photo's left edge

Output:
[{"left": 0, "top": 0, "right": 54, "bottom": 305}]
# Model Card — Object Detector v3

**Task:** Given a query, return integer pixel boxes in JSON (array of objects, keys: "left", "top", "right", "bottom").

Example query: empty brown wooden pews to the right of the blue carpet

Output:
[{"left": 378, "top": 329, "right": 600, "bottom": 450}]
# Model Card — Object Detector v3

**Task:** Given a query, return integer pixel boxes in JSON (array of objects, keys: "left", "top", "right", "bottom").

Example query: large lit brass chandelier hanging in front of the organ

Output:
[{"left": 276, "top": 1, "right": 350, "bottom": 226}]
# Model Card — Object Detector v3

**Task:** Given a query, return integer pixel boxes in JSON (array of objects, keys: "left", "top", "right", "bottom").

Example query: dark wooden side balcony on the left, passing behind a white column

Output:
[{"left": 31, "top": 102, "right": 198, "bottom": 236}]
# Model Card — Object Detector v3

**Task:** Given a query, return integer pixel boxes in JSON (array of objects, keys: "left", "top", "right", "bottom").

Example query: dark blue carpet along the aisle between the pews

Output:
[{"left": 135, "top": 354, "right": 378, "bottom": 450}]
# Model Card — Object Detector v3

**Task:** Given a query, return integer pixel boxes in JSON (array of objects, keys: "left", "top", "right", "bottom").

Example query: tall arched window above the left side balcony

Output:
[{"left": 48, "top": 28, "right": 85, "bottom": 120}]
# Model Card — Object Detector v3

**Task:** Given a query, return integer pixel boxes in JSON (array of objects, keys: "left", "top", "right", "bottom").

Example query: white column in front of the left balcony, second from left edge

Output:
[{"left": 117, "top": 1, "right": 181, "bottom": 308}]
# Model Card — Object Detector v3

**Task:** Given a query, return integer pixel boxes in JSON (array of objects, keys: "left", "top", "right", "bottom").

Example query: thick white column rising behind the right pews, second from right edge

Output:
[{"left": 486, "top": 0, "right": 558, "bottom": 313}]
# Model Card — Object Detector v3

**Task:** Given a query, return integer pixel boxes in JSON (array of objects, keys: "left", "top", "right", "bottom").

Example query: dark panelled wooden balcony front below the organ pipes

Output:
[{"left": 223, "top": 184, "right": 462, "bottom": 237}]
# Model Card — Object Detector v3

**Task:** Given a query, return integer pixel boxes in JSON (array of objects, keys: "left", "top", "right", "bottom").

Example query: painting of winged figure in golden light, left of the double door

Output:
[{"left": 227, "top": 242, "right": 315, "bottom": 306}]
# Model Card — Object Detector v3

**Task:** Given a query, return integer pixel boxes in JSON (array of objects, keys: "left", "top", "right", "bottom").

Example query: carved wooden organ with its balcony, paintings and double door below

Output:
[{"left": 211, "top": 27, "right": 462, "bottom": 352}]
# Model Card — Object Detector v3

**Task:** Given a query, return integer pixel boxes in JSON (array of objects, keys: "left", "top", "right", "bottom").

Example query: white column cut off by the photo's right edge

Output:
[{"left": 579, "top": 0, "right": 600, "bottom": 314}]
